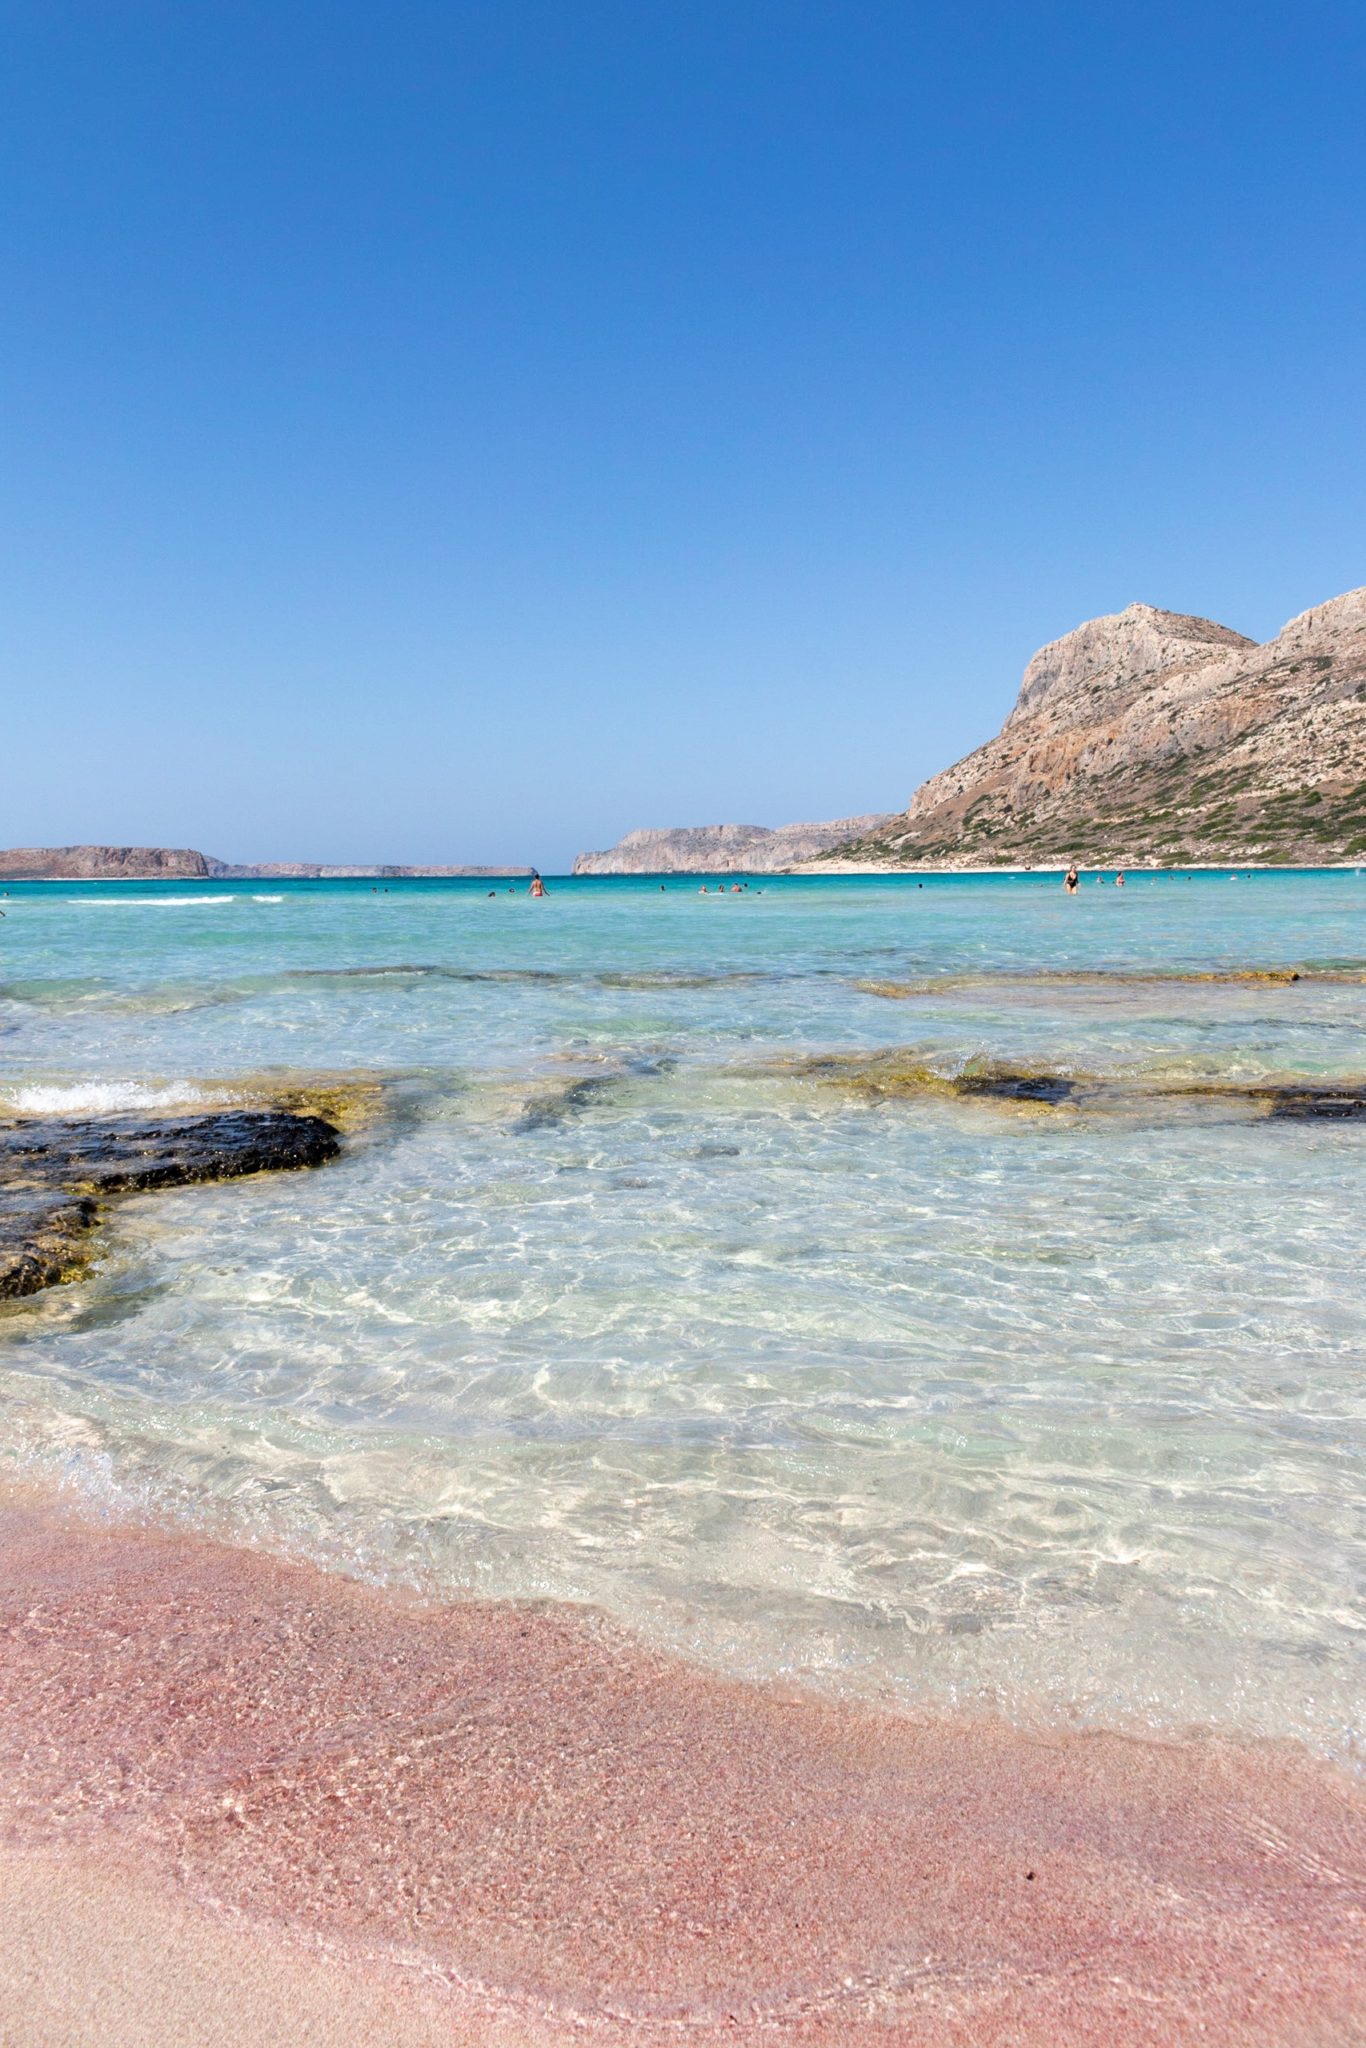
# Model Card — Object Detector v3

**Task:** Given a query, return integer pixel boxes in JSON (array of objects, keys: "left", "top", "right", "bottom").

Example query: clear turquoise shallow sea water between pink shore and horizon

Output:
[{"left": 0, "top": 872, "right": 1366, "bottom": 1753}]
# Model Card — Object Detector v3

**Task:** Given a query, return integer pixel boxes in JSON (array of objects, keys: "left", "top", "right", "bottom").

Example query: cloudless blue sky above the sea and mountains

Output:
[{"left": 0, "top": 0, "right": 1366, "bottom": 868}]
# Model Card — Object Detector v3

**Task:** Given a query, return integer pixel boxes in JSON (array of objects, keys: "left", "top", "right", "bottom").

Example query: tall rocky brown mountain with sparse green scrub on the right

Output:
[{"left": 821, "top": 588, "right": 1366, "bottom": 868}]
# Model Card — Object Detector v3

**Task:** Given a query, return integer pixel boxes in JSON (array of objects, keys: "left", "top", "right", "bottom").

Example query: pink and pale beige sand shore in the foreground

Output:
[{"left": 0, "top": 1493, "right": 1366, "bottom": 2048}]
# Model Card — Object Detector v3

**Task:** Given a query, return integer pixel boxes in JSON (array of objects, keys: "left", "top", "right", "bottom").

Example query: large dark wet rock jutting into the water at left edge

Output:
[{"left": 0, "top": 1110, "right": 340, "bottom": 1298}]
